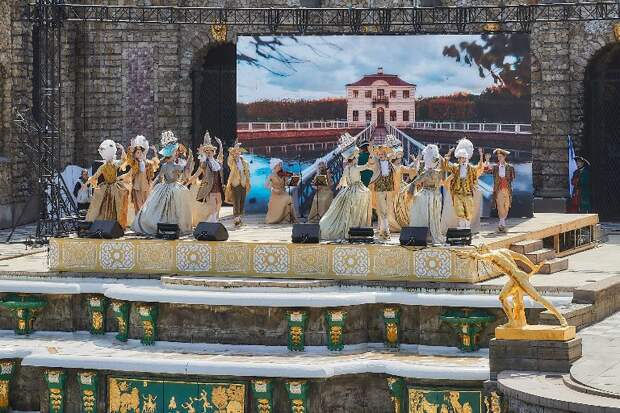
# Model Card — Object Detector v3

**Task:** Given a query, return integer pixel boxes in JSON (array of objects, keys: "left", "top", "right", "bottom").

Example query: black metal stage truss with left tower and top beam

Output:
[{"left": 18, "top": 0, "right": 620, "bottom": 240}]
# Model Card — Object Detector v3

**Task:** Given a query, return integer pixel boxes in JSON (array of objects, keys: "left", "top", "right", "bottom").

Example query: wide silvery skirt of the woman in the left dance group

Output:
[{"left": 131, "top": 182, "right": 192, "bottom": 235}]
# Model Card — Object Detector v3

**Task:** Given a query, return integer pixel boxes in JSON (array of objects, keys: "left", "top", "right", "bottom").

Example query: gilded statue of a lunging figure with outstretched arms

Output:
[{"left": 458, "top": 245, "right": 568, "bottom": 329}]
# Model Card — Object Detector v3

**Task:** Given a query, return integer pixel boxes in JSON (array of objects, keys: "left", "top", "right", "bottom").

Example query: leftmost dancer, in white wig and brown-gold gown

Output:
[{"left": 86, "top": 139, "right": 131, "bottom": 228}]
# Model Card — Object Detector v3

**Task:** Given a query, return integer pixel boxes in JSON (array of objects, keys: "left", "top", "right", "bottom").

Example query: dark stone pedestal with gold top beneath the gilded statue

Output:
[{"left": 489, "top": 332, "right": 581, "bottom": 380}]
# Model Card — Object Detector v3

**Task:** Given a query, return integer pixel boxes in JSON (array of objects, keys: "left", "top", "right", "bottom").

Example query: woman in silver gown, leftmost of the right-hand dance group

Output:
[{"left": 319, "top": 146, "right": 373, "bottom": 240}]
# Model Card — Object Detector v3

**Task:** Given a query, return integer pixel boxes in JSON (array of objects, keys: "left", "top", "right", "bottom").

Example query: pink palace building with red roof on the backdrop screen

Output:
[{"left": 346, "top": 67, "right": 416, "bottom": 127}]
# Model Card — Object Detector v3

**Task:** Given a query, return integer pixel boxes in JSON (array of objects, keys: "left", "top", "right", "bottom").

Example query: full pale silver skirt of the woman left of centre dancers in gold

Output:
[{"left": 319, "top": 181, "right": 372, "bottom": 240}]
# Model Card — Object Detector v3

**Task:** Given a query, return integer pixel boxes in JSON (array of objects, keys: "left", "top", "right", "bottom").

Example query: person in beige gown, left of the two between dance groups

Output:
[{"left": 265, "top": 158, "right": 296, "bottom": 224}]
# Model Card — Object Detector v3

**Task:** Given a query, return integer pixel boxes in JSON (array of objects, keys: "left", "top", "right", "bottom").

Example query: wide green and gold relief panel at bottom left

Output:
[{"left": 108, "top": 377, "right": 249, "bottom": 413}]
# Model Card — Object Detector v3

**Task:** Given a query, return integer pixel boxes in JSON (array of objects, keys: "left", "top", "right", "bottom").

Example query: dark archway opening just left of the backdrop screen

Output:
[{"left": 192, "top": 43, "right": 237, "bottom": 149}]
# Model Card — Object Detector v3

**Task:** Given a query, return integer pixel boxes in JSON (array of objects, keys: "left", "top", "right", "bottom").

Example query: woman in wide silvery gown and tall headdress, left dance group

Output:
[{"left": 131, "top": 131, "right": 194, "bottom": 235}]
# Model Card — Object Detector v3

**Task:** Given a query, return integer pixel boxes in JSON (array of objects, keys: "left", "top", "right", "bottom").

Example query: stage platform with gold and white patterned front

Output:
[{"left": 49, "top": 214, "right": 598, "bottom": 283}]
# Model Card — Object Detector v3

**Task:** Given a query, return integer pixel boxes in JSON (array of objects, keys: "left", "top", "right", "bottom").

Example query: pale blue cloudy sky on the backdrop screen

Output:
[{"left": 237, "top": 35, "right": 512, "bottom": 102}]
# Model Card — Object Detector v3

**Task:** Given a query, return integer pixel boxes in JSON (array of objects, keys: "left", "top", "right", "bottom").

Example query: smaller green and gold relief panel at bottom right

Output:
[{"left": 407, "top": 387, "right": 483, "bottom": 413}]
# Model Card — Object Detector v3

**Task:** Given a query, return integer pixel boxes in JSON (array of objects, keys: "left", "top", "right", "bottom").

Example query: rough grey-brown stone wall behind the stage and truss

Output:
[{"left": 0, "top": 0, "right": 614, "bottom": 221}]
